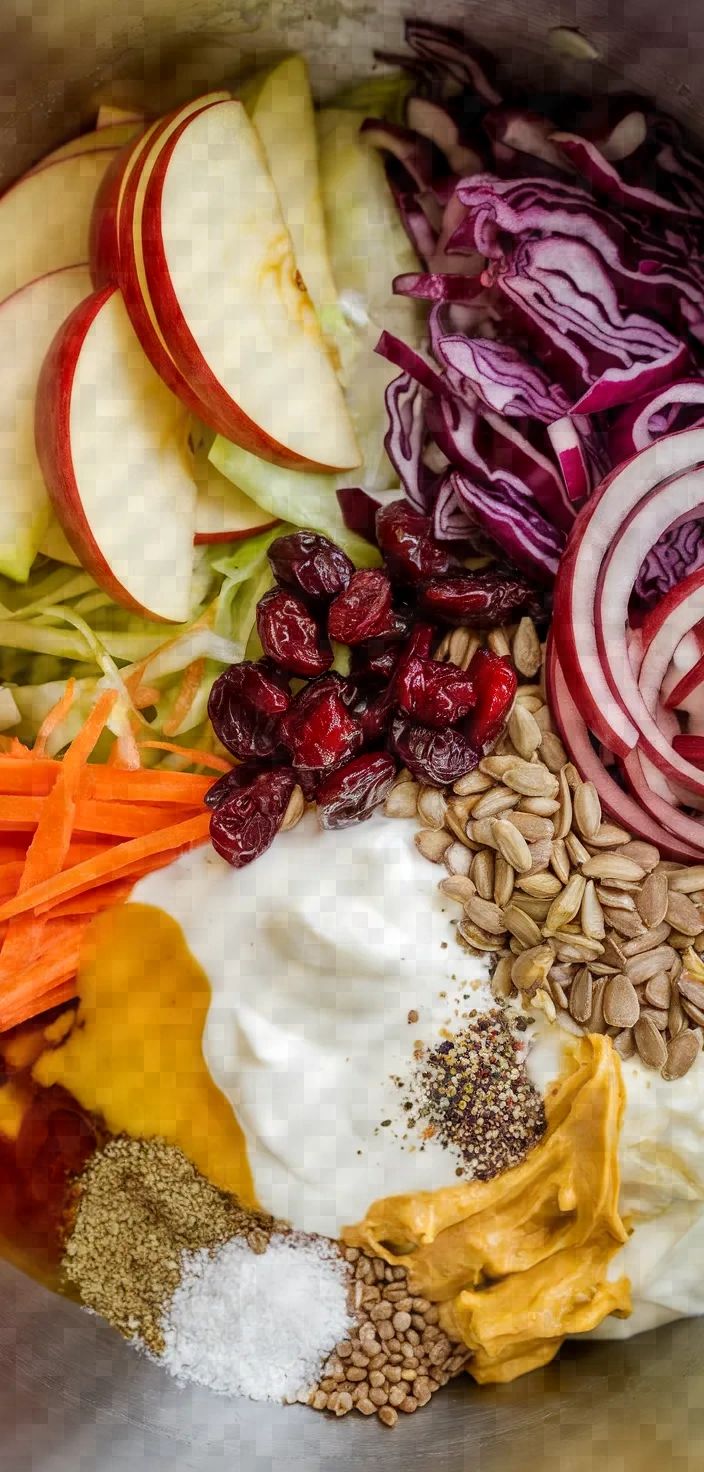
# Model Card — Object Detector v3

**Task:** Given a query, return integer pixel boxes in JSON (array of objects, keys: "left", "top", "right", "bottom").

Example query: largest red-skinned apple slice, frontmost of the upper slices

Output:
[{"left": 143, "top": 102, "right": 359, "bottom": 470}]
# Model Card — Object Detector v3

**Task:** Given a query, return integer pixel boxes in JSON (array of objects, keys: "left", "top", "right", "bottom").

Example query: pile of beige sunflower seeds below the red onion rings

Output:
[{"left": 386, "top": 618, "right": 704, "bottom": 1079}]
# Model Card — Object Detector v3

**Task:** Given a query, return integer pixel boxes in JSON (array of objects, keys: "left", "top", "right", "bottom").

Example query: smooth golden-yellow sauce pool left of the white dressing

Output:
[{"left": 34, "top": 904, "right": 255, "bottom": 1206}]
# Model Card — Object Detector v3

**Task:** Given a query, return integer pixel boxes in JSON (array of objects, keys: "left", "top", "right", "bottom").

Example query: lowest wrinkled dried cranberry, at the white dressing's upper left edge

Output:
[{"left": 211, "top": 767, "right": 296, "bottom": 868}]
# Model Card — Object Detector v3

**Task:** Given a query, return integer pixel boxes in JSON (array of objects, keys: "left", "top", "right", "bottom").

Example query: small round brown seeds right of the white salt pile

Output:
[{"left": 308, "top": 1247, "right": 470, "bottom": 1426}]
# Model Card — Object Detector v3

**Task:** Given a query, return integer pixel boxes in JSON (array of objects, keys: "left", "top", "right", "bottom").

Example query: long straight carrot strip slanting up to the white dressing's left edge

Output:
[{"left": 0, "top": 813, "right": 211, "bottom": 920}]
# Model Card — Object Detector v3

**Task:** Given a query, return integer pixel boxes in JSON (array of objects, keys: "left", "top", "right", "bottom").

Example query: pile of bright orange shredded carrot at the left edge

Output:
[{"left": 0, "top": 683, "right": 215, "bottom": 1030}]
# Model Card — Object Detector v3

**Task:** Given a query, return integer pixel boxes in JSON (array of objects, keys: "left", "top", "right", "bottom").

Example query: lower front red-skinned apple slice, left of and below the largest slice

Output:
[{"left": 35, "top": 287, "right": 196, "bottom": 623}]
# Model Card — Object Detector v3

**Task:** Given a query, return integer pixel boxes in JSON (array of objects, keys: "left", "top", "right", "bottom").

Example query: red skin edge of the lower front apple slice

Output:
[{"left": 34, "top": 287, "right": 178, "bottom": 623}]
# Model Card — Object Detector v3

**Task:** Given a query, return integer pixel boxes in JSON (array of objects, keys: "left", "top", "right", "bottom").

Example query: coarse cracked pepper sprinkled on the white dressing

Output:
[{"left": 404, "top": 1011, "right": 545, "bottom": 1181}]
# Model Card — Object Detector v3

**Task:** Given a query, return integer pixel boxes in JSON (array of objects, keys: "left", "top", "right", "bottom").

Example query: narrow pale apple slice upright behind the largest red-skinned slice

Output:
[{"left": 239, "top": 56, "right": 340, "bottom": 336}]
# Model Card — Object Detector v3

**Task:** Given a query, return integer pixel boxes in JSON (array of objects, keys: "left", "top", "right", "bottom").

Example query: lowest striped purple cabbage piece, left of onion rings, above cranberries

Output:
[{"left": 452, "top": 473, "right": 564, "bottom": 583}]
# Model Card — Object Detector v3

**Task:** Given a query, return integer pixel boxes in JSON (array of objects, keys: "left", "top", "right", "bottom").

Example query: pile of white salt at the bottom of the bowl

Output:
[{"left": 161, "top": 1235, "right": 353, "bottom": 1401}]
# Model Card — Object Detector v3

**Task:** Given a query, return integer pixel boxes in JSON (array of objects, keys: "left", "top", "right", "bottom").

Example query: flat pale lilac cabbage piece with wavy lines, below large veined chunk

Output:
[{"left": 434, "top": 333, "right": 570, "bottom": 424}]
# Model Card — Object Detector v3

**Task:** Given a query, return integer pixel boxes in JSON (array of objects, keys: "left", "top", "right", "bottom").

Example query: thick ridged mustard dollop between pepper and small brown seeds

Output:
[{"left": 342, "top": 1036, "right": 630, "bottom": 1384}]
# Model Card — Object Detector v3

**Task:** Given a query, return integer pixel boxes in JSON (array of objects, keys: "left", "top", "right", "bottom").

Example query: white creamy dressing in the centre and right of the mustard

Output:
[{"left": 134, "top": 814, "right": 704, "bottom": 1338}]
